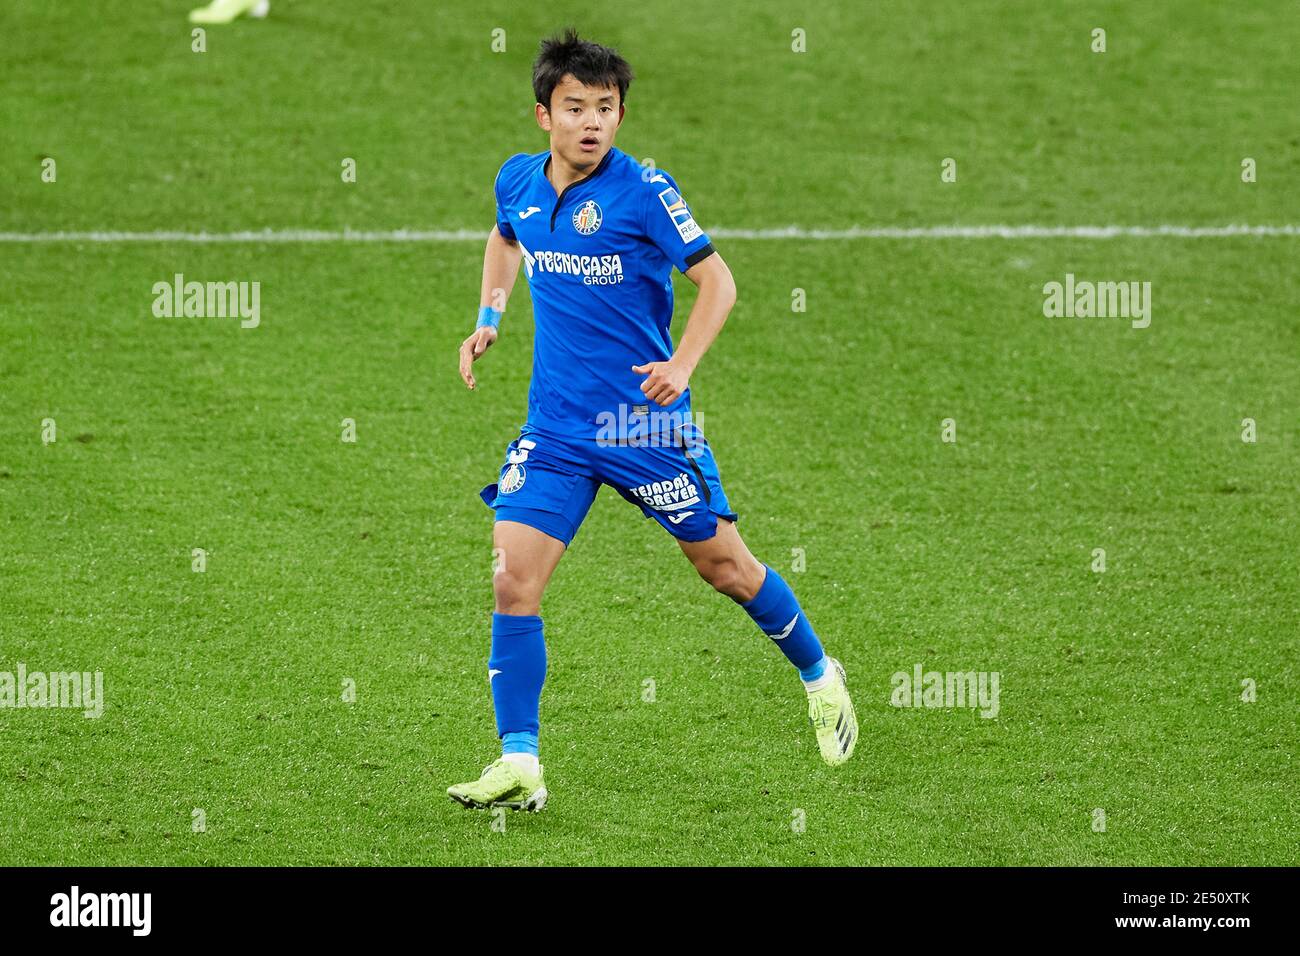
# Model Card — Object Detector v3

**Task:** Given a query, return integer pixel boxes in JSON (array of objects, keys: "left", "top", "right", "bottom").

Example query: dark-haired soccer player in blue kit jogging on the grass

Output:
[{"left": 447, "top": 30, "right": 858, "bottom": 810}]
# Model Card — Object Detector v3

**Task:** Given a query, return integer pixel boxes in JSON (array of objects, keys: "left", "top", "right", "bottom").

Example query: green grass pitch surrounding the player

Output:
[{"left": 0, "top": 0, "right": 1300, "bottom": 865}]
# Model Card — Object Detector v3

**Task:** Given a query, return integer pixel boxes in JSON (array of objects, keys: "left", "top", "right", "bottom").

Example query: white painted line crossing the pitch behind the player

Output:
[{"left": 0, "top": 224, "right": 1300, "bottom": 243}]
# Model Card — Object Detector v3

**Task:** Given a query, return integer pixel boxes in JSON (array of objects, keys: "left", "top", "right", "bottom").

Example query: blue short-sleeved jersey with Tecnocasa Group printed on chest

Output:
[{"left": 495, "top": 147, "right": 714, "bottom": 438}]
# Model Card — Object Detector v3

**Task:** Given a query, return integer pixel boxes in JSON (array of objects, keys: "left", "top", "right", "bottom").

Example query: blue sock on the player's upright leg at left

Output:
[{"left": 488, "top": 614, "right": 546, "bottom": 756}]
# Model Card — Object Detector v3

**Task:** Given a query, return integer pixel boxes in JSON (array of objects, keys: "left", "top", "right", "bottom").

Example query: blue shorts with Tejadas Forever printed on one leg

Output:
[{"left": 478, "top": 423, "right": 737, "bottom": 546}]
